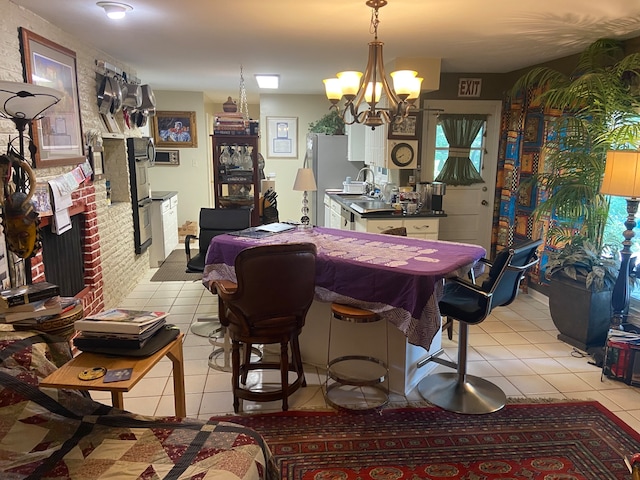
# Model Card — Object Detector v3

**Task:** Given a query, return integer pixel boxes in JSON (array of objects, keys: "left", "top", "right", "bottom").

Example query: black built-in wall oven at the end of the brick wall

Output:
[{"left": 127, "top": 137, "right": 156, "bottom": 254}]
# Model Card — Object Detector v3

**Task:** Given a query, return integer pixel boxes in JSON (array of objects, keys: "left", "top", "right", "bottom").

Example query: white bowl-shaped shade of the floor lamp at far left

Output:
[{"left": 0, "top": 82, "right": 62, "bottom": 120}]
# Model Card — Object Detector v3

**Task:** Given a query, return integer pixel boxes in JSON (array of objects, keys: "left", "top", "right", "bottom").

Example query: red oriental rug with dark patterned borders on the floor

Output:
[{"left": 212, "top": 402, "right": 640, "bottom": 480}]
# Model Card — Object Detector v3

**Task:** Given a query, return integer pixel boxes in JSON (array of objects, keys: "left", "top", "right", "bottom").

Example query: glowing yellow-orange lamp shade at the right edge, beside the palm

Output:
[{"left": 600, "top": 150, "right": 640, "bottom": 197}]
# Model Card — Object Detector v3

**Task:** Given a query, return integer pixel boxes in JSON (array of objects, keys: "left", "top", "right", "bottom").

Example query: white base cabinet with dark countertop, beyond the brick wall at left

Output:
[{"left": 149, "top": 192, "right": 178, "bottom": 268}]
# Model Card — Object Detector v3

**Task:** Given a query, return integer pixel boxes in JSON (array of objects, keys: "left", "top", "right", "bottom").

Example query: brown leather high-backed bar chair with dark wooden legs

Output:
[{"left": 216, "top": 243, "right": 316, "bottom": 413}]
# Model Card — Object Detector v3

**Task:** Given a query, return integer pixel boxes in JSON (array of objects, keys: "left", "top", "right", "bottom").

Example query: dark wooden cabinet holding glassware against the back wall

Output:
[{"left": 211, "top": 135, "right": 260, "bottom": 226}]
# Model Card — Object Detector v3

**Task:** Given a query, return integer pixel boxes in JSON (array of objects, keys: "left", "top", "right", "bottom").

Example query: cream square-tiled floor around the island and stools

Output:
[{"left": 91, "top": 269, "right": 640, "bottom": 431}]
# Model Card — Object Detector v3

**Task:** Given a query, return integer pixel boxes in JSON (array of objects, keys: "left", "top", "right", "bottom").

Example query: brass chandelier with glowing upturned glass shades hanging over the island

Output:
[{"left": 323, "top": 0, "right": 422, "bottom": 129}]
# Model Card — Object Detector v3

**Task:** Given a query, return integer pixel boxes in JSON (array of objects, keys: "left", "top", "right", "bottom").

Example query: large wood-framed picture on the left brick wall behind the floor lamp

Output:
[{"left": 20, "top": 27, "right": 84, "bottom": 168}]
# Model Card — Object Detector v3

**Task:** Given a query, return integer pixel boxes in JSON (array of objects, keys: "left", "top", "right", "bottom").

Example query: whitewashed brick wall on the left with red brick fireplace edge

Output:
[{"left": 0, "top": 0, "right": 149, "bottom": 312}]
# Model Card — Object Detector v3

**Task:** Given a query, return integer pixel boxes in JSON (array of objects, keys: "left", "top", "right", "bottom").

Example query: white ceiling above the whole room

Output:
[{"left": 11, "top": 0, "right": 640, "bottom": 102}]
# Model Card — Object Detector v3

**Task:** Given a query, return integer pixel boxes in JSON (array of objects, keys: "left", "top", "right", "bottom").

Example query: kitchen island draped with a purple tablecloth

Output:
[{"left": 203, "top": 227, "right": 485, "bottom": 395}]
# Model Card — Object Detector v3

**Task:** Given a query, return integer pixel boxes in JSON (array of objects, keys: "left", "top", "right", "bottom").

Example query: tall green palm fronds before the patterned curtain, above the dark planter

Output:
[{"left": 511, "top": 39, "right": 640, "bottom": 251}]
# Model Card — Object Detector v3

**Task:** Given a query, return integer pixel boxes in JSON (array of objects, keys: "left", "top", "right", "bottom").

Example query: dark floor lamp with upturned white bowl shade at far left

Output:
[{"left": 0, "top": 82, "right": 63, "bottom": 286}]
